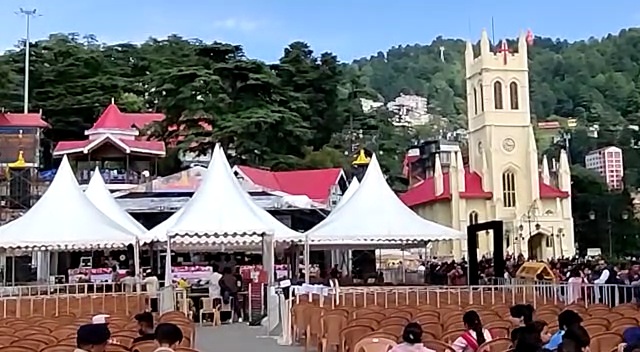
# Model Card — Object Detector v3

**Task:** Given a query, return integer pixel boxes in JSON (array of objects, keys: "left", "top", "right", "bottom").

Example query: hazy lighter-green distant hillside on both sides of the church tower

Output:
[{"left": 355, "top": 28, "right": 640, "bottom": 187}]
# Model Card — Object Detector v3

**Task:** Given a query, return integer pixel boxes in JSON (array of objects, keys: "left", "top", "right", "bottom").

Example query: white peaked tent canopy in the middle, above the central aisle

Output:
[{"left": 167, "top": 145, "right": 304, "bottom": 245}]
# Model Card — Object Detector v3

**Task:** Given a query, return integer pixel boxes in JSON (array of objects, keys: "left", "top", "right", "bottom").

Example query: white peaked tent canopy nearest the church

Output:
[{"left": 305, "top": 155, "right": 465, "bottom": 247}]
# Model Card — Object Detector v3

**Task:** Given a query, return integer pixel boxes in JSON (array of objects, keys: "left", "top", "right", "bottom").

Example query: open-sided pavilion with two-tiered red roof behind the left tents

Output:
[{"left": 53, "top": 101, "right": 166, "bottom": 185}]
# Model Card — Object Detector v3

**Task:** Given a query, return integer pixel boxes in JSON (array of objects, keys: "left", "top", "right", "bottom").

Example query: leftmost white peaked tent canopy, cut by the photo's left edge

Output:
[{"left": 0, "top": 156, "right": 137, "bottom": 251}]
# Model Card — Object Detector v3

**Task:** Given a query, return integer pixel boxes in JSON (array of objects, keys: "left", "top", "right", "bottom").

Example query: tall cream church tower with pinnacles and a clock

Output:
[{"left": 465, "top": 31, "right": 540, "bottom": 220}]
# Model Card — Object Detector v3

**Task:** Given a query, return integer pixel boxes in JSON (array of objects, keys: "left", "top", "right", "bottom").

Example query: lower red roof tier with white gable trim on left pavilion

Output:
[{"left": 53, "top": 135, "right": 165, "bottom": 156}]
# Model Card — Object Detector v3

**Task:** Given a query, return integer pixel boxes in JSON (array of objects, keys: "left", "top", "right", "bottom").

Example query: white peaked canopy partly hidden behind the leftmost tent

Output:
[{"left": 84, "top": 167, "right": 147, "bottom": 236}]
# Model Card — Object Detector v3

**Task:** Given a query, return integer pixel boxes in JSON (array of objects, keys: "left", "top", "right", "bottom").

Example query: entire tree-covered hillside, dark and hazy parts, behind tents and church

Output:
[{"left": 0, "top": 29, "right": 640, "bottom": 185}]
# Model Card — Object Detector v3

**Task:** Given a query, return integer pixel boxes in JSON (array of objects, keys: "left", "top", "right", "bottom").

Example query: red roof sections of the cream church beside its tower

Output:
[{"left": 400, "top": 170, "right": 569, "bottom": 207}]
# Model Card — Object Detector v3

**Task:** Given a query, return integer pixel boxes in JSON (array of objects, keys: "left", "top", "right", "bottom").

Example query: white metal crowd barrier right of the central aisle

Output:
[{"left": 278, "top": 280, "right": 640, "bottom": 345}]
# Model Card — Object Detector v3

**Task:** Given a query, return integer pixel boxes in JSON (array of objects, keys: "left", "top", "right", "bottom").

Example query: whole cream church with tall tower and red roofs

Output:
[{"left": 400, "top": 32, "right": 575, "bottom": 259}]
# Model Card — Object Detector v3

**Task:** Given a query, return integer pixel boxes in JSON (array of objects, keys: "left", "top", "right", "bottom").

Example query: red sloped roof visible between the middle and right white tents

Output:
[{"left": 238, "top": 166, "right": 343, "bottom": 203}]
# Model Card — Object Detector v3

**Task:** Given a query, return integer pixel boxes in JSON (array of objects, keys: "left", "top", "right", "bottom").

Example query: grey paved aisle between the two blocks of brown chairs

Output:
[{"left": 195, "top": 323, "right": 302, "bottom": 352}]
